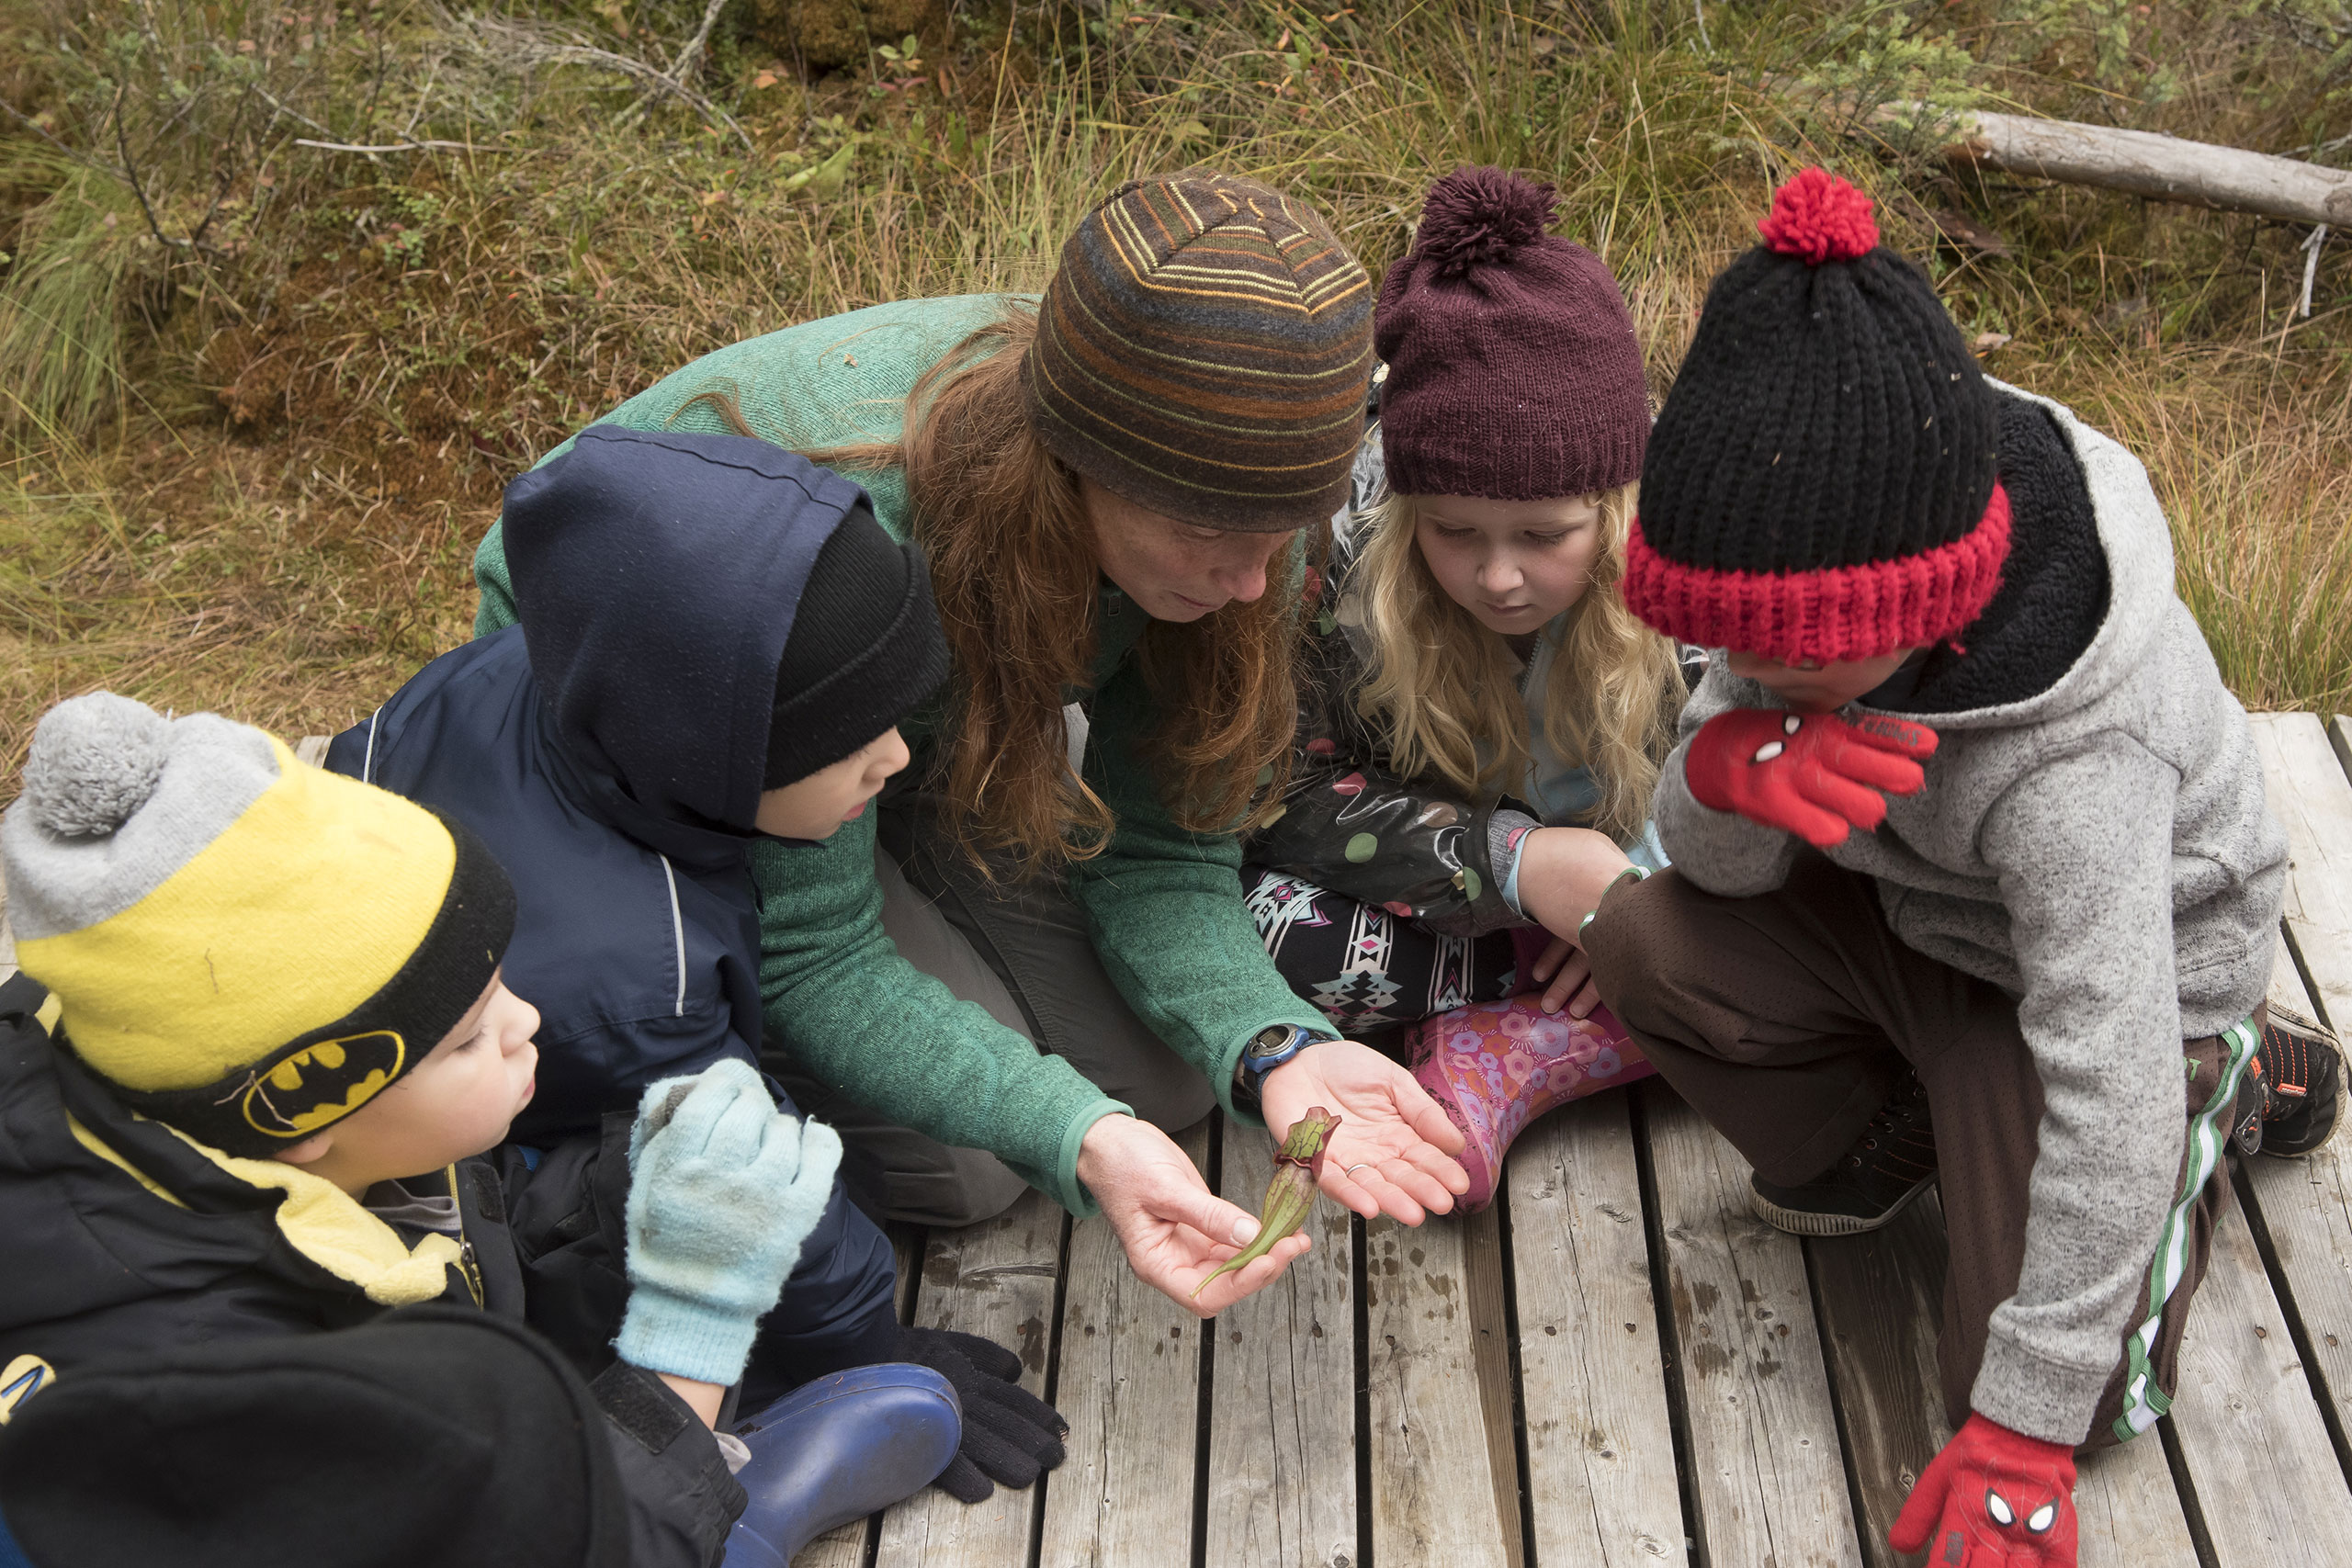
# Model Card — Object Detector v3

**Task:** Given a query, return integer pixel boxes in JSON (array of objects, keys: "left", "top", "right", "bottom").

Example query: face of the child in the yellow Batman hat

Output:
[{"left": 277, "top": 976, "right": 538, "bottom": 1197}]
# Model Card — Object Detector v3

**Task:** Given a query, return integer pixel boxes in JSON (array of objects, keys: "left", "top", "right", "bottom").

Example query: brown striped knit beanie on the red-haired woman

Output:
[{"left": 1021, "top": 169, "right": 1371, "bottom": 534}]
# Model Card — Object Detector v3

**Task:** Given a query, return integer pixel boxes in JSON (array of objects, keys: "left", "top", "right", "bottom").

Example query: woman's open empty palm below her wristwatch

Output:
[{"left": 1244, "top": 1039, "right": 1470, "bottom": 1222}]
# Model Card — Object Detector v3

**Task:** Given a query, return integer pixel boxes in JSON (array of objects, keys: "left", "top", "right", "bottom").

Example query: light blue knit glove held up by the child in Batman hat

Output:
[{"left": 614, "top": 1058, "right": 842, "bottom": 1384}]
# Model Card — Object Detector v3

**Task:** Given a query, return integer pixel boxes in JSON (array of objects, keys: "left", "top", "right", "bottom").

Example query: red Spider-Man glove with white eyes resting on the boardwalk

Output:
[{"left": 1886, "top": 1416, "right": 2075, "bottom": 1568}]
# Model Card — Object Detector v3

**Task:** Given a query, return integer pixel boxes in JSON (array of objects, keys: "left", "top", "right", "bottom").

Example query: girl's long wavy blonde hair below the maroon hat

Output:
[{"left": 1360, "top": 484, "right": 1681, "bottom": 841}]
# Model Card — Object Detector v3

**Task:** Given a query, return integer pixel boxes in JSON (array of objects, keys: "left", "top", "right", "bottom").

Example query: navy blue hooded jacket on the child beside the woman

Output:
[{"left": 327, "top": 425, "right": 896, "bottom": 1375}]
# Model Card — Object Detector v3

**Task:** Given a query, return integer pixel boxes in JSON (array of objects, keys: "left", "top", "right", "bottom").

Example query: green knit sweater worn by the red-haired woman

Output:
[{"left": 473, "top": 294, "right": 1327, "bottom": 1215}]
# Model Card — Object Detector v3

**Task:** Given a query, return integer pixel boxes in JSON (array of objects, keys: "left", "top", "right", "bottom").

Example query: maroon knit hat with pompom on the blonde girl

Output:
[{"left": 1374, "top": 169, "right": 1649, "bottom": 501}]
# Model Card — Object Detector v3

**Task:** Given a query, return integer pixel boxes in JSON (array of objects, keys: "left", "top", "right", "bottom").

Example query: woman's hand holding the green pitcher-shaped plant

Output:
[{"left": 1077, "top": 1112, "right": 1317, "bottom": 1316}]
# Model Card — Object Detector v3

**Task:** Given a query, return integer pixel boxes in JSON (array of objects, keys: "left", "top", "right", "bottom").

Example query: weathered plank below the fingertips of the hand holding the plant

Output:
[{"left": 1204, "top": 1122, "right": 1364, "bottom": 1568}]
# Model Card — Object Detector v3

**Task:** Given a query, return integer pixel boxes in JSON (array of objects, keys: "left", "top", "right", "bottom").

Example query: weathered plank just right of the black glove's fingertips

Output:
[{"left": 1037, "top": 1119, "right": 1204, "bottom": 1568}]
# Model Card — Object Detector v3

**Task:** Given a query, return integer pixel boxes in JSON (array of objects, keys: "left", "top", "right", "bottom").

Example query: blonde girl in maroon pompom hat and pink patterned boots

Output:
[{"left": 1244, "top": 169, "right": 1684, "bottom": 1208}]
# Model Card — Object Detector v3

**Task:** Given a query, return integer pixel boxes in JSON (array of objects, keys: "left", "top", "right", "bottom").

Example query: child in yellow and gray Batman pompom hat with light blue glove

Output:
[{"left": 0, "top": 694, "right": 957, "bottom": 1568}]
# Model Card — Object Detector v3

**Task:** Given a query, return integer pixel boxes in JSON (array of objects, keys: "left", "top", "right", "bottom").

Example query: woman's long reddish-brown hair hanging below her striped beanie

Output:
[{"left": 696, "top": 303, "right": 1298, "bottom": 877}]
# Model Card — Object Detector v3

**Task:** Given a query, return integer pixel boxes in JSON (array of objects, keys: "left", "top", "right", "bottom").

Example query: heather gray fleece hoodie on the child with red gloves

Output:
[{"left": 1656, "top": 383, "right": 2286, "bottom": 1443}]
